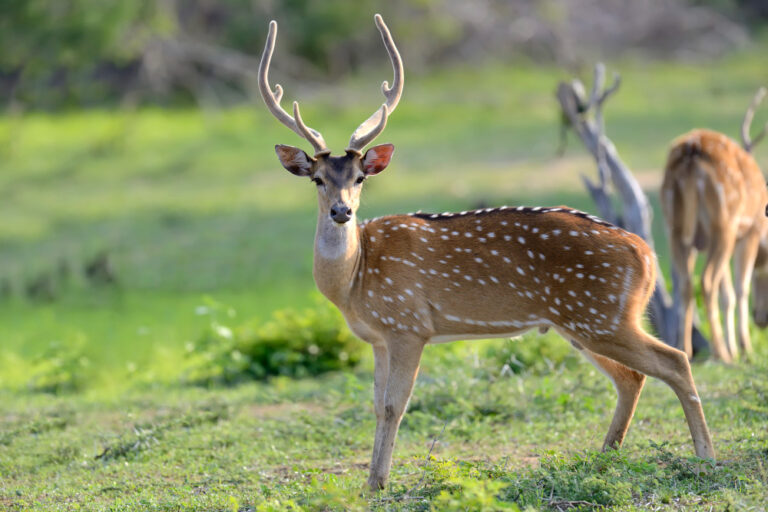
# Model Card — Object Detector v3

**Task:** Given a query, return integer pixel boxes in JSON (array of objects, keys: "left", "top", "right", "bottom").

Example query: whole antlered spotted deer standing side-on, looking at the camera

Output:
[{"left": 259, "top": 15, "right": 714, "bottom": 490}]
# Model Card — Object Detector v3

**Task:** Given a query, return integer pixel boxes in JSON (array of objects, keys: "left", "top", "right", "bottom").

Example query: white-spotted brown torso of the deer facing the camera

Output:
[{"left": 350, "top": 207, "right": 654, "bottom": 339}]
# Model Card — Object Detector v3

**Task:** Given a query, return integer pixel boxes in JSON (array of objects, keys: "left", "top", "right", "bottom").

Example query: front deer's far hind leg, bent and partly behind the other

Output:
[{"left": 574, "top": 343, "right": 645, "bottom": 451}]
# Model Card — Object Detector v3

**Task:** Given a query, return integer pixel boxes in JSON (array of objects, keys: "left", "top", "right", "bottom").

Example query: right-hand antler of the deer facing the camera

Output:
[{"left": 347, "top": 14, "right": 405, "bottom": 153}]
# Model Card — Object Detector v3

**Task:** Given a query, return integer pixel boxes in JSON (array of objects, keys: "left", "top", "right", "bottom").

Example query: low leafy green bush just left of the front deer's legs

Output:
[{"left": 184, "top": 300, "right": 364, "bottom": 384}]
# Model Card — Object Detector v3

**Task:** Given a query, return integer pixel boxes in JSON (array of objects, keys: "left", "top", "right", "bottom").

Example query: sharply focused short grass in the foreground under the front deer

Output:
[{"left": 0, "top": 335, "right": 768, "bottom": 510}]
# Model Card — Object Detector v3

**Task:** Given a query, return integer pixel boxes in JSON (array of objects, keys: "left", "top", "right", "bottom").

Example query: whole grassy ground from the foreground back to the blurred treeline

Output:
[{"left": 0, "top": 47, "right": 768, "bottom": 510}]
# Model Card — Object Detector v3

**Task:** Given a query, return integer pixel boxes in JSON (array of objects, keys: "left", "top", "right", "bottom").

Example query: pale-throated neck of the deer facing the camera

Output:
[{"left": 312, "top": 213, "right": 361, "bottom": 309}]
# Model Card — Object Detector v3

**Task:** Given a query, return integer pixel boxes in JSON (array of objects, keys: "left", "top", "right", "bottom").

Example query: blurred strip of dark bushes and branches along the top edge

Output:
[{"left": 0, "top": 0, "right": 768, "bottom": 109}]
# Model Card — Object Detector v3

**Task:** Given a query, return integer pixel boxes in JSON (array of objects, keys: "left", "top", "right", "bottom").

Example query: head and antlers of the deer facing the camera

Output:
[{"left": 259, "top": 14, "right": 403, "bottom": 224}]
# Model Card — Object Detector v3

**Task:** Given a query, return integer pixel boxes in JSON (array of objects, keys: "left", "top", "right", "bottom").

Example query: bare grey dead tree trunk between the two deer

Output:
[{"left": 557, "top": 63, "right": 709, "bottom": 353}]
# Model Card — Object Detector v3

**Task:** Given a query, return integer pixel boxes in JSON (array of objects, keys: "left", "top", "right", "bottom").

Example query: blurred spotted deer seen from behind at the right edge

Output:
[{"left": 661, "top": 89, "right": 768, "bottom": 362}]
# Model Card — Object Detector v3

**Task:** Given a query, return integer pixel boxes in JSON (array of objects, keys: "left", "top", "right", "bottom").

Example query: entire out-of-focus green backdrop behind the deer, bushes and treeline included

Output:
[{"left": 0, "top": 0, "right": 768, "bottom": 393}]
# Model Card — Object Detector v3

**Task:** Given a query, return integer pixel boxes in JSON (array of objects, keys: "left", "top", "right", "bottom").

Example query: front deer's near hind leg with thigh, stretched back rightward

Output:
[{"left": 585, "top": 326, "right": 715, "bottom": 458}]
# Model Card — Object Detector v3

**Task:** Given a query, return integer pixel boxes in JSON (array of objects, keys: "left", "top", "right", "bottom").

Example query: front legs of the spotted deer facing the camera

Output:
[{"left": 368, "top": 338, "right": 424, "bottom": 491}]
